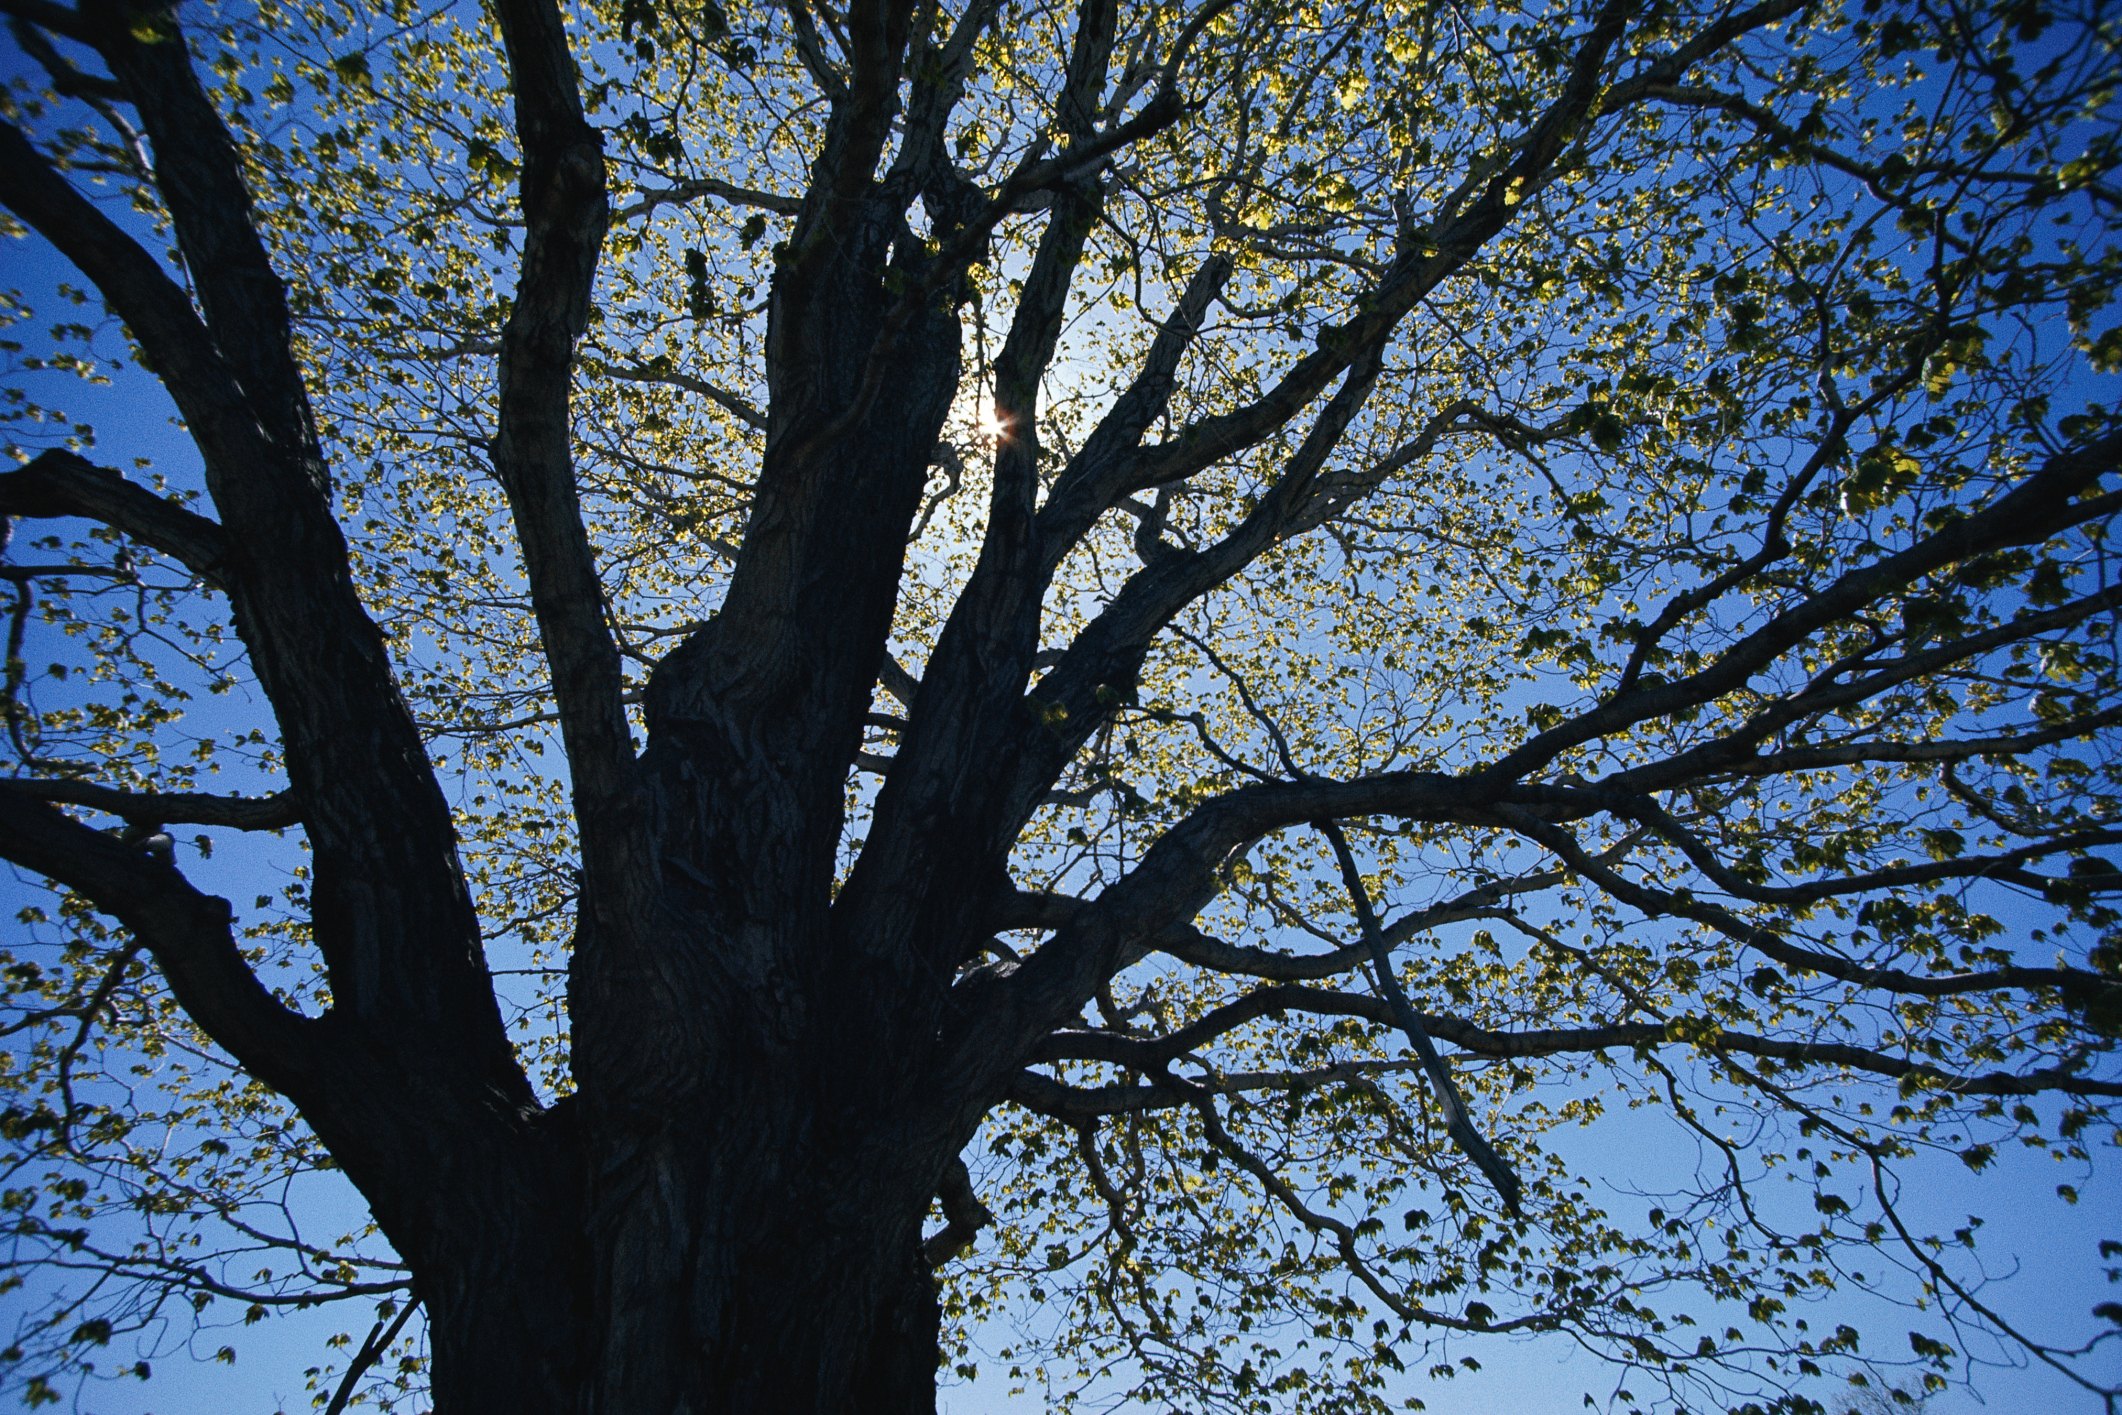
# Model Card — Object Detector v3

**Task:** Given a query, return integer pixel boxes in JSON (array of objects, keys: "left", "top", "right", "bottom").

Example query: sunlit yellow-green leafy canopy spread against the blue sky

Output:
[{"left": 0, "top": 0, "right": 2122, "bottom": 1411}]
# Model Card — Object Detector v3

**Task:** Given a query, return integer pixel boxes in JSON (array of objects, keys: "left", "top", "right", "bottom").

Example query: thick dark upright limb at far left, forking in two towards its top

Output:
[{"left": 0, "top": 24, "right": 533, "bottom": 1103}]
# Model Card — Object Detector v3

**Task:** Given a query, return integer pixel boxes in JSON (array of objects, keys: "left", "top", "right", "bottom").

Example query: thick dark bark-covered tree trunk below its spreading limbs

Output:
[{"left": 398, "top": 891, "right": 966, "bottom": 1415}]
